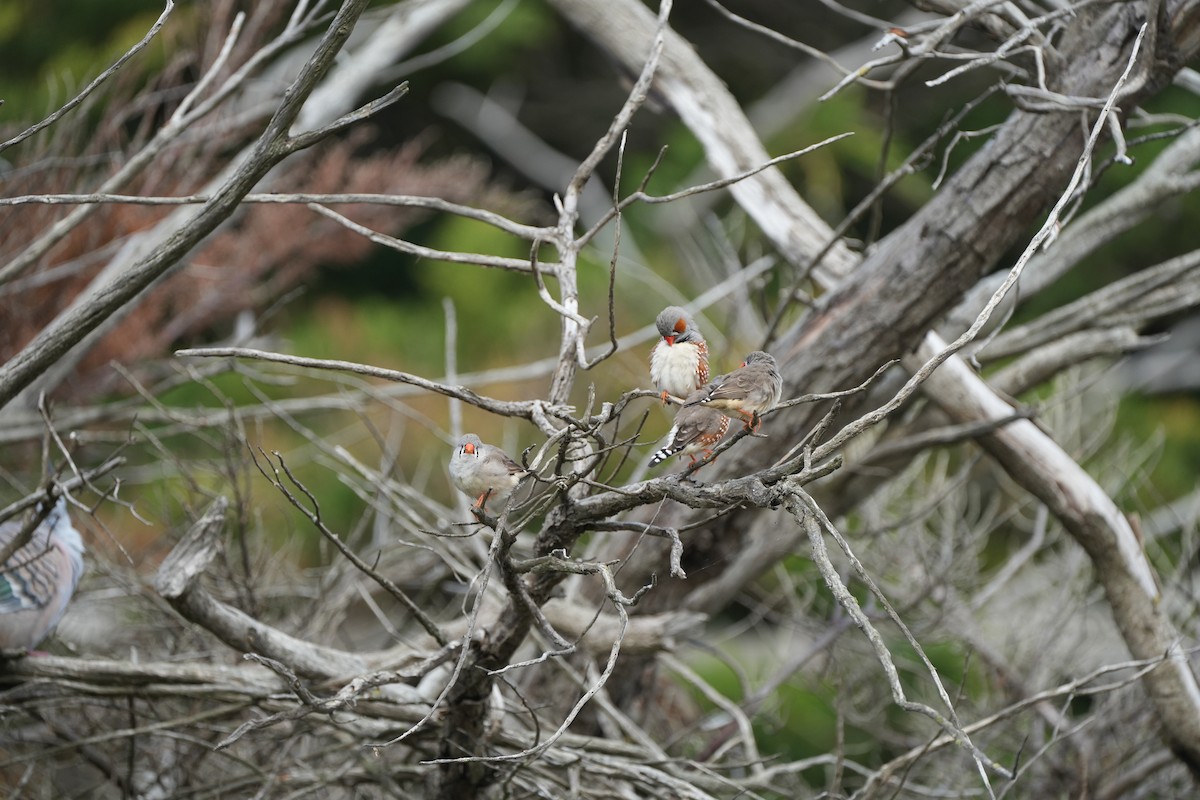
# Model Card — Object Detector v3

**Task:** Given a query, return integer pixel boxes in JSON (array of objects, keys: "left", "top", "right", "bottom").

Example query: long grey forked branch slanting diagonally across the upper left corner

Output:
[{"left": 0, "top": 0, "right": 386, "bottom": 408}]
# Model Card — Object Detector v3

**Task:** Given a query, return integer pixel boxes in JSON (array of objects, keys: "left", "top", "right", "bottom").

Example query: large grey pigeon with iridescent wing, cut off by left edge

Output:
[{"left": 0, "top": 497, "right": 83, "bottom": 650}]
